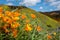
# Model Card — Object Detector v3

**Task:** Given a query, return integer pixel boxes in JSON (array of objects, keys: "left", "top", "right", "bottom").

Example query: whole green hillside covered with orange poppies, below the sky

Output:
[{"left": 0, "top": 6, "right": 60, "bottom": 40}]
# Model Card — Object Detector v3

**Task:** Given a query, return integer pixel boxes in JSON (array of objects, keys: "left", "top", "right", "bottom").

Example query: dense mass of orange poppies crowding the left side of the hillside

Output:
[{"left": 0, "top": 7, "right": 20, "bottom": 37}]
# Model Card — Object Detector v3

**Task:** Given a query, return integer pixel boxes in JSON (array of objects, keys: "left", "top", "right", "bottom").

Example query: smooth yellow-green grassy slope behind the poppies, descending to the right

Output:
[{"left": 20, "top": 8, "right": 59, "bottom": 28}]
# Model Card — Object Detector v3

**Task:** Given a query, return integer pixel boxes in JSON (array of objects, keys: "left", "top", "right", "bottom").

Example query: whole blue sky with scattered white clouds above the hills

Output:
[{"left": 0, "top": 0, "right": 60, "bottom": 12}]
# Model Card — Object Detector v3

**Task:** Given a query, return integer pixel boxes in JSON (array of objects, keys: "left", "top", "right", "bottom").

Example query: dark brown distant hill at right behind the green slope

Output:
[{"left": 41, "top": 10, "right": 60, "bottom": 21}]
